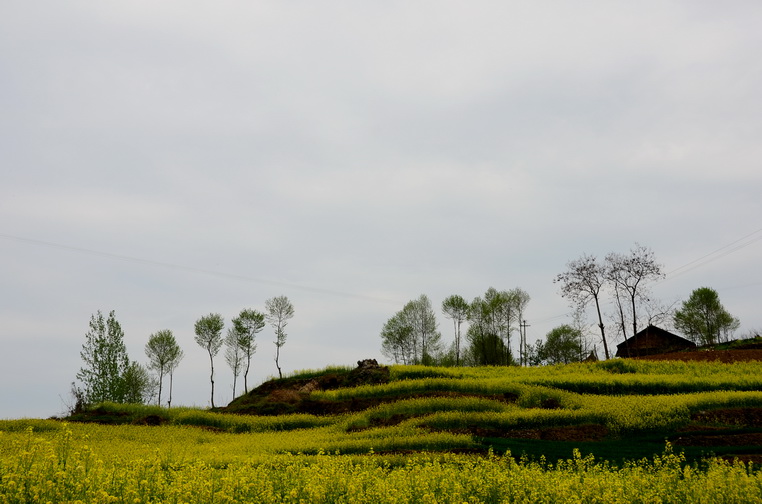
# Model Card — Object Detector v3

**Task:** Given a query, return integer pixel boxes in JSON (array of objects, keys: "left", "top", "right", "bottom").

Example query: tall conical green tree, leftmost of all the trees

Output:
[{"left": 77, "top": 310, "right": 130, "bottom": 404}]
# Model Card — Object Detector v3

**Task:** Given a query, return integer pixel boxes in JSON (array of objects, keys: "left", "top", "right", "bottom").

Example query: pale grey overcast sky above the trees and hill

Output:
[{"left": 0, "top": 0, "right": 762, "bottom": 418}]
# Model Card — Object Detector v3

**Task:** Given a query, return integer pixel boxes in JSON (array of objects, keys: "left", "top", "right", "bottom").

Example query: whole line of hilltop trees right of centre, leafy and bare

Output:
[{"left": 381, "top": 243, "right": 740, "bottom": 366}]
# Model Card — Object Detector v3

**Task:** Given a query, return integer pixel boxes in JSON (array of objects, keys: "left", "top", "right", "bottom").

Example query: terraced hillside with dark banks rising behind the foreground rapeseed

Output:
[{"left": 62, "top": 359, "right": 762, "bottom": 461}]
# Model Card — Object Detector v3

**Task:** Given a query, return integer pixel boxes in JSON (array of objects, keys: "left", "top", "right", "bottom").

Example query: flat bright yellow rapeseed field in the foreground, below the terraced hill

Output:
[{"left": 0, "top": 424, "right": 762, "bottom": 504}]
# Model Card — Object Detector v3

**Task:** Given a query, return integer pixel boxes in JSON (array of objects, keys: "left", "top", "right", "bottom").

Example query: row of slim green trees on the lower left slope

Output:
[{"left": 72, "top": 296, "right": 294, "bottom": 409}]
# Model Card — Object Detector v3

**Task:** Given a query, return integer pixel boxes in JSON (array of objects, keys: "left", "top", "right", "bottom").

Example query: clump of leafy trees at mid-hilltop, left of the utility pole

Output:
[{"left": 381, "top": 287, "right": 530, "bottom": 366}]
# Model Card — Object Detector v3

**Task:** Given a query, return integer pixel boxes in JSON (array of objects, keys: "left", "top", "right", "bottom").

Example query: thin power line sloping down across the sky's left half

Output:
[{"left": 0, "top": 233, "right": 403, "bottom": 305}]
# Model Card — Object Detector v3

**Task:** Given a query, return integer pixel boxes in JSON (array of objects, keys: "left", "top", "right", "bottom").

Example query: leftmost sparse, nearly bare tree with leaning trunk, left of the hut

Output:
[{"left": 553, "top": 254, "right": 609, "bottom": 359}]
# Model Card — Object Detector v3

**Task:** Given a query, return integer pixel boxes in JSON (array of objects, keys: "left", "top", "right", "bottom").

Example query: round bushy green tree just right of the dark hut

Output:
[{"left": 673, "top": 287, "right": 741, "bottom": 345}]
